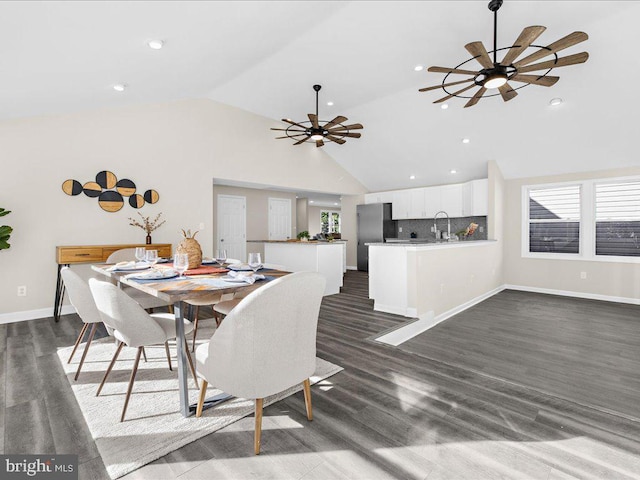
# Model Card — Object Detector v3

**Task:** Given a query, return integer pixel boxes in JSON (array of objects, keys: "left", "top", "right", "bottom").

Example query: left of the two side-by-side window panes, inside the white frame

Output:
[{"left": 529, "top": 185, "right": 580, "bottom": 254}]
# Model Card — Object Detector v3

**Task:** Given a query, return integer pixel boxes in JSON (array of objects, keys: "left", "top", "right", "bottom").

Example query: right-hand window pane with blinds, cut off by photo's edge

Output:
[{"left": 595, "top": 181, "right": 640, "bottom": 257}]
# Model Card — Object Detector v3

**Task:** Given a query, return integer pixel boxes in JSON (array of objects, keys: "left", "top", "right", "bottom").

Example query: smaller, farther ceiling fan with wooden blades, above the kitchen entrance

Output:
[{"left": 271, "top": 85, "right": 364, "bottom": 147}]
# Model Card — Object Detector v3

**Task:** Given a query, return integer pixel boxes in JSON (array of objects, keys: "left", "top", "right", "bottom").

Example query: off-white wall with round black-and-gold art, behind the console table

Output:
[{"left": 0, "top": 99, "right": 365, "bottom": 320}]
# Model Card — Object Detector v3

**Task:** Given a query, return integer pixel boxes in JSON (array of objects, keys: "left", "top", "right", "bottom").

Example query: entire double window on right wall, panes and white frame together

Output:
[{"left": 522, "top": 177, "right": 640, "bottom": 263}]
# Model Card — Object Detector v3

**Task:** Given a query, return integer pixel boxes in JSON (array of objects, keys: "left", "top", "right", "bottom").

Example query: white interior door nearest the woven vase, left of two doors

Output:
[{"left": 213, "top": 195, "right": 247, "bottom": 262}]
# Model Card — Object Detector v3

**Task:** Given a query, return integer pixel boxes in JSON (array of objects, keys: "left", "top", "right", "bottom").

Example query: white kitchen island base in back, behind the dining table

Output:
[{"left": 247, "top": 240, "right": 346, "bottom": 295}]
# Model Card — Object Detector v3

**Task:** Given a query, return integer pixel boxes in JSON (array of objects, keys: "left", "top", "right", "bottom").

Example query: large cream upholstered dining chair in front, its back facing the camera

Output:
[{"left": 196, "top": 272, "right": 326, "bottom": 455}]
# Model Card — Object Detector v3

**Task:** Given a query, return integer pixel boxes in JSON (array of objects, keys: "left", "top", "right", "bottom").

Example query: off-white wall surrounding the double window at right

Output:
[{"left": 504, "top": 167, "right": 640, "bottom": 301}]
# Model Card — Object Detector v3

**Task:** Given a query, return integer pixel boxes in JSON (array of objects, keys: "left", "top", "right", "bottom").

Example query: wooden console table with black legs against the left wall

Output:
[{"left": 53, "top": 243, "right": 171, "bottom": 322}]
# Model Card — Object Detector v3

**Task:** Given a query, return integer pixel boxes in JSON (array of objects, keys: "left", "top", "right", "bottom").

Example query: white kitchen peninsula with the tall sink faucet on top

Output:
[{"left": 368, "top": 240, "right": 502, "bottom": 334}]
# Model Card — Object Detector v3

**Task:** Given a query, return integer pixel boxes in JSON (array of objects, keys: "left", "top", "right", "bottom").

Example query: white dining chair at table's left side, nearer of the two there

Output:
[{"left": 89, "top": 278, "right": 198, "bottom": 422}]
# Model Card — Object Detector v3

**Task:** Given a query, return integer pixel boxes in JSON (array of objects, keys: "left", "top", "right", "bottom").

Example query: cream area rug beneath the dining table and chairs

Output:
[{"left": 58, "top": 322, "right": 342, "bottom": 479}]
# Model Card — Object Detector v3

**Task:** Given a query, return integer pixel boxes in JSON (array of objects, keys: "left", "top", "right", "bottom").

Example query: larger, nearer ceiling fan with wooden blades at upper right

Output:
[{"left": 419, "top": 0, "right": 589, "bottom": 108}]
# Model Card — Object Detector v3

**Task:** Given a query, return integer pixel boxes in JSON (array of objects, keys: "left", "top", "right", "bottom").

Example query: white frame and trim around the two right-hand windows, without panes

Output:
[{"left": 521, "top": 176, "right": 640, "bottom": 263}]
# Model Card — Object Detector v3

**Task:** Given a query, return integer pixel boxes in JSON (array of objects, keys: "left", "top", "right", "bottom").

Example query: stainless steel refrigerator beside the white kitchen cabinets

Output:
[{"left": 357, "top": 203, "right": 396, "bottom": 272}]
